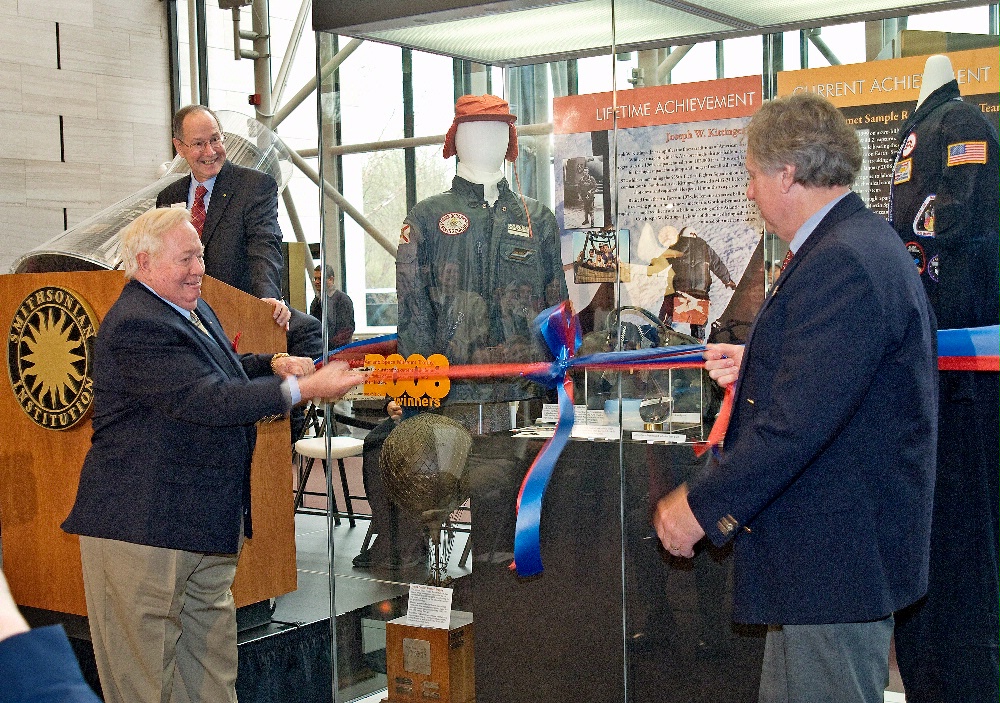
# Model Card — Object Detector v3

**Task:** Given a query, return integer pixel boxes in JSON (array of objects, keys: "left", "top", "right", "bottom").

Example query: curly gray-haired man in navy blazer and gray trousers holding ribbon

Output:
[{"left": 654, "top": 94, "right": 937, "bottom": 703}]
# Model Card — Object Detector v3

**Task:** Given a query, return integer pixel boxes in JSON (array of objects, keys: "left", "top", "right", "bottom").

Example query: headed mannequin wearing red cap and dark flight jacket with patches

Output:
[{"left": 396, "top": 95, "right": 567, "bottom": 424}]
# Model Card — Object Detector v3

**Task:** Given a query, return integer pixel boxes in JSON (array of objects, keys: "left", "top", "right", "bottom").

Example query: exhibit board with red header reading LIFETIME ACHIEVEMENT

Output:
[{"left": 553, "top": 76, "right": 763, "bottom": 341}]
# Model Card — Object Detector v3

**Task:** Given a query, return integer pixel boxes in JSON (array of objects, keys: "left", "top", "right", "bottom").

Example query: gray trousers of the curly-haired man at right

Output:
[{"left": 759, "top": 615, "right": 893, "bottom": 703}]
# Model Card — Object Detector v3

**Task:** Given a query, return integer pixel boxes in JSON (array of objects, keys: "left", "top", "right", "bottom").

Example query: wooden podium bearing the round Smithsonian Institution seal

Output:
[{"left": 0, "top": 271, "right": 296, "bottom": 615}]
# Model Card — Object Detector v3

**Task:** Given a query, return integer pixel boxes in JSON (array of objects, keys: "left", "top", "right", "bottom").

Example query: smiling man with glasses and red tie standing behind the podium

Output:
[{"left": 156, "top": 105, "right": 288, "bottom": 325}]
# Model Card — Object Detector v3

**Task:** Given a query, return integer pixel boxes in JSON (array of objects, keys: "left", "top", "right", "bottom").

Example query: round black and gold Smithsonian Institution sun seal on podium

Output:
[{"left": 7, "top": 286, "right": 97, "bottom": 430}]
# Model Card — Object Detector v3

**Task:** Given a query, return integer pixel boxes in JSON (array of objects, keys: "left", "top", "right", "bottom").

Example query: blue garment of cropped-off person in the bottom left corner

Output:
[{"left": 0, "top": 625, "right": 101, "bottom": 703}]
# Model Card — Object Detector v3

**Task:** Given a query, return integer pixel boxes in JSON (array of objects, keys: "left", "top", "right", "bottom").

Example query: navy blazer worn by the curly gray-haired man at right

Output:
[{"left": 689, "top": 193, "right": 937, "bottom": 624}]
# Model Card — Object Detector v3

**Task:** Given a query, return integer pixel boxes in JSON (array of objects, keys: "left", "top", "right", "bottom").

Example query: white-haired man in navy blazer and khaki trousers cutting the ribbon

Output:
[{"left": 63, "top": 208, "right": 363, "bottom": 703}]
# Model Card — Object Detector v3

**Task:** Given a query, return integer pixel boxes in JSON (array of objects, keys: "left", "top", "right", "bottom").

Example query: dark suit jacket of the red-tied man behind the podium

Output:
[{"left": 156, "top": 161, "right": 283, "bottom": 299}]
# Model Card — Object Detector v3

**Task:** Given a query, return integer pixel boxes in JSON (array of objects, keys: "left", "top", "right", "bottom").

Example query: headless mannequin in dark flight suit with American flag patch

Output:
[{"left": 890, "top": 51, "right": 1000, "bottom": 703}]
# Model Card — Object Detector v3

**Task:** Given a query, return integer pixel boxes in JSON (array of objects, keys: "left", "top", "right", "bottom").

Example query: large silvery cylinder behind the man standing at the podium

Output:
[{"left": 11, "top": 110, "right": 292, "bottom": 273}]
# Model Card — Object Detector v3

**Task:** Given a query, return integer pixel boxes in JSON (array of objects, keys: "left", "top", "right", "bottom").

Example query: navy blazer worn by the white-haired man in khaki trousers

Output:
[{"left": 62, "top": 281, "right": 288, "bottom": 554}]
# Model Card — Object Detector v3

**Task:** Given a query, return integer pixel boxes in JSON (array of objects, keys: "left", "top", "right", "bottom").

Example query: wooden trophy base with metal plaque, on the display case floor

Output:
[{"left": 385, "top": 610, "right": 476, "bottom": 703}]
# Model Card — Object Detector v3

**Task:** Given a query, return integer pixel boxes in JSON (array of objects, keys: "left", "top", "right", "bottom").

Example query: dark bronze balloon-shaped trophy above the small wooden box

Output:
[{"left": 379, "top": 413, "right": 472, "bottom": 584}]
